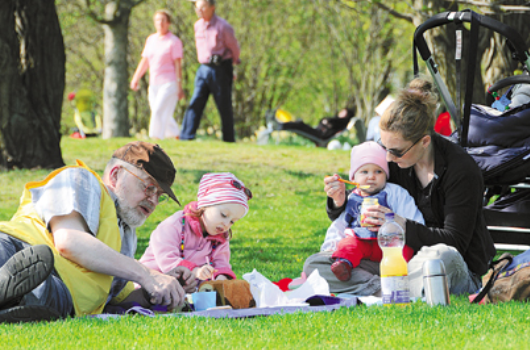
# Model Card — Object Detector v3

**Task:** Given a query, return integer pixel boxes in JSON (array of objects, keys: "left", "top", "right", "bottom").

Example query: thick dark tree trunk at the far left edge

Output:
[{"left": 0, "top": 0, "right": 65, "bottom": 169}]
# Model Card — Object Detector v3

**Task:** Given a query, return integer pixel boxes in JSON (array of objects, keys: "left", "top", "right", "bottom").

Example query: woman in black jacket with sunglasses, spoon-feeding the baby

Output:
[{"left": 304, "top": 79, "right": 495, "bottom": 297}]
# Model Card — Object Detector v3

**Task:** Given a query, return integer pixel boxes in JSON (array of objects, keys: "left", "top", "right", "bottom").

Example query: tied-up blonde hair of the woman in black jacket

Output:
[{"left": 379, "top": 78, "right": 438, "bottom": 142}]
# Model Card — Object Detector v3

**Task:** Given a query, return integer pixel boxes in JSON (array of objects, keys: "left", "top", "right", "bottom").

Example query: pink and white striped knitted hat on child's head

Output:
[{"left": 197, "top": 173, "right": 250, "bottom": 215}]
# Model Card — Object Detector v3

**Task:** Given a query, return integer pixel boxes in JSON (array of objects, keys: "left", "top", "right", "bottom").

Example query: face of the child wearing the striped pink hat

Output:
[{"left": 202, "top": 203, "right": 245, "bottom": 236}]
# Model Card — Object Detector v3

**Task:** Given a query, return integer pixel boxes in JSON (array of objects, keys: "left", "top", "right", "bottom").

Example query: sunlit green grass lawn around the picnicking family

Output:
[{"left": 0, "top": 137, "right": 530, "bottom": 349}]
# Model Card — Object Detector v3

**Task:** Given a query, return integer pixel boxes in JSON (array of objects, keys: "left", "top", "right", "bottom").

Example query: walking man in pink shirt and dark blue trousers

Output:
[{"left": 180, "top": 0, "right": 240, "bottom": 142}]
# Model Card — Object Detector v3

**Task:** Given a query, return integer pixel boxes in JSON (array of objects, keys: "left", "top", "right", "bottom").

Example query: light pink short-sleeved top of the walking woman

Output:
[{"left": 142, "top": 32, "right": 182, "bottom": 85}]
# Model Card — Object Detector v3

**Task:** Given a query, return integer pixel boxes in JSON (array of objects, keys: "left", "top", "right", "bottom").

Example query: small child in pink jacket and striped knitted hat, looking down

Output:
[{"left": 140, "top": 173, "right": 252, "bottom": 281}]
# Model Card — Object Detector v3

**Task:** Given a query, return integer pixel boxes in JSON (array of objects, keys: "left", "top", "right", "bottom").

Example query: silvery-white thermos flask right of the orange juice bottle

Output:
[{"left": 423, "top": 259, "right": 451, "bottom": 306}]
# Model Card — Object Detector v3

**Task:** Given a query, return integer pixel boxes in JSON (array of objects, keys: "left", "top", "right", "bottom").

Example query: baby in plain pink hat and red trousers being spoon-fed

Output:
[{"left": 321, "top": 141, "right": 424, "bottom": 281}]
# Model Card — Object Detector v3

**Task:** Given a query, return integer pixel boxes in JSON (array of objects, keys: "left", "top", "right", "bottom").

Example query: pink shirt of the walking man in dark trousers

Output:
[{"left": 195, "top": 15, "right": 240, "bottom": 64}]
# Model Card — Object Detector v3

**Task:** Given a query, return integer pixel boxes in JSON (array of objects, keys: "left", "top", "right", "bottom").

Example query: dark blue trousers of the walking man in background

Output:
[{"left": 180, "top": 60, "right": 235, "bottom": 142}]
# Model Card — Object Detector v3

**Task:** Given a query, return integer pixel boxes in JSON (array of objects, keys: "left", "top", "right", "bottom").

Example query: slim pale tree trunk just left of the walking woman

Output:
[{"left": 102, "top": 2, "right": 131, "bottom": 139}]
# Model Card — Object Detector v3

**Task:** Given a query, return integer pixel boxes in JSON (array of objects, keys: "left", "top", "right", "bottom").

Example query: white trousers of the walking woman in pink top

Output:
[{"left": 149, "top": 82, "right": 180, "bottom": 139}]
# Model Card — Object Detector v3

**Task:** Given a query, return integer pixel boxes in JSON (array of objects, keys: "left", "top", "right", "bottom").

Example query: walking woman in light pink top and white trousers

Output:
[{"left": 131, "top": 10, "right": 184, "bottom": 139}]
